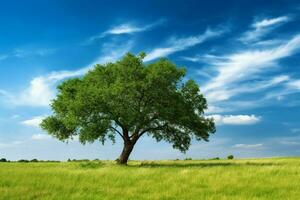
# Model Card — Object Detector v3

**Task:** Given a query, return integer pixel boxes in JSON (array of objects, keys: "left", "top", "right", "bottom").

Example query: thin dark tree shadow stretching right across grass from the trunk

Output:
[{"left": 135, "top": 161, "right": 282, "bottom": 168}]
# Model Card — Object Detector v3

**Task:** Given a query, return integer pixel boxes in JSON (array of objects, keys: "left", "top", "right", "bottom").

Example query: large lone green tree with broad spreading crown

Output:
[{"left": 41, "top": 53, "right": 215, "bottom": 164}]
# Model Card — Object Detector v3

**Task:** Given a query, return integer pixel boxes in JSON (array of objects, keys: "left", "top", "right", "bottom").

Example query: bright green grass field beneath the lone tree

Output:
[{"left": 0, "top": 158, "right": 300, "bottom": 200}]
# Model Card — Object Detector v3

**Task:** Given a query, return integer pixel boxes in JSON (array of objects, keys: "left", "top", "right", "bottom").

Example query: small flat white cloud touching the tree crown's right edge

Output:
[{"left": 208, "top": 115, "right": 261, "bottom": 125}]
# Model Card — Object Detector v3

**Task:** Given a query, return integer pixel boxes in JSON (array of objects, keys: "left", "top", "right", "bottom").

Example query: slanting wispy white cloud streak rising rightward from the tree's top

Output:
[{"left": 144, "top": 29, "right": 224, "bottom": 62}]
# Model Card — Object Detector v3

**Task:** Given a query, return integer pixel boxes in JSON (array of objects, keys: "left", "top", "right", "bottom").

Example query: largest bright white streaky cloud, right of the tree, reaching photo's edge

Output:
[{"left": 202, "top": 35, "right": 300, "bottom": 110}]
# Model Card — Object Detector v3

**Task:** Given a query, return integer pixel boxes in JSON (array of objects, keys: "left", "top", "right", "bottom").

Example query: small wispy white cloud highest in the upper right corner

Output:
[{"left": 240, "top": 16, "right": 292, "bottom": 43}]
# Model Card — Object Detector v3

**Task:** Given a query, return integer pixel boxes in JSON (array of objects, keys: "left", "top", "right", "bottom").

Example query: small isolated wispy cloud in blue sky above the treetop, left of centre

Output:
[{"left": 84, "top": 19, "right": 166, "bottom": 45}]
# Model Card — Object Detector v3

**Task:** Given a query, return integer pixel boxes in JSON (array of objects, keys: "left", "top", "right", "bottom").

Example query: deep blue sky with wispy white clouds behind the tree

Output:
[{"left": 0, "top": 0, "right": 300, "bottom": 160}]
